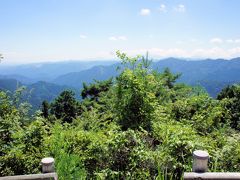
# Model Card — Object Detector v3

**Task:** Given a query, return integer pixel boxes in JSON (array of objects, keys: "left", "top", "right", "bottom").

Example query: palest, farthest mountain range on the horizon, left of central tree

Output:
[{"left": 0, "top": 61, "right": 116, "bottom": 84}]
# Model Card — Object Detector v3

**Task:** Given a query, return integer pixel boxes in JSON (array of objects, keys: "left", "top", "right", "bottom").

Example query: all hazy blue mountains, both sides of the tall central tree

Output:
[{"left": 0, "top": 58, "right": 240, "bottom": 107}]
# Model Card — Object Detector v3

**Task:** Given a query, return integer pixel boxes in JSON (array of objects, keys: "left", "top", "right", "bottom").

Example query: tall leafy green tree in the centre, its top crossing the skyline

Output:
[{"left": 114, "top": 52, "right": 156, "bottom": 130}]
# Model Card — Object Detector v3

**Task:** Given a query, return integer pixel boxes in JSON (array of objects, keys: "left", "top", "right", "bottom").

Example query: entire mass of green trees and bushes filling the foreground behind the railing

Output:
[{"left": 0, "top": 52, "right": 240, "bottom": 180}]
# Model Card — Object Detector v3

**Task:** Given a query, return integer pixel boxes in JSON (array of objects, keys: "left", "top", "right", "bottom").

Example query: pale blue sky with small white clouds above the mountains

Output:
[{"left": 0, "top": 0, "right": 240, "bottom": 64}]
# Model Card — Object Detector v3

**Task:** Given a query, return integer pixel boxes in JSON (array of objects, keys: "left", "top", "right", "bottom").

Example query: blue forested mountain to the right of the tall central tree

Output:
[{"left": 153, "top": 58, "right": 240, "bottom": 97}]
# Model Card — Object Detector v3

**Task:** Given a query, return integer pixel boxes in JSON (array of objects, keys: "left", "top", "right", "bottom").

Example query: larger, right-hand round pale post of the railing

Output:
[{"left": 193, "top": 150, "right": 209, "bottom": 172}]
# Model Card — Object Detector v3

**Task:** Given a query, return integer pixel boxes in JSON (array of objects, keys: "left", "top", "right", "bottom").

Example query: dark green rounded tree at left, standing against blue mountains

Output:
[{"left": 50, "top": 90, "right": 78, "bottom": 123}]
